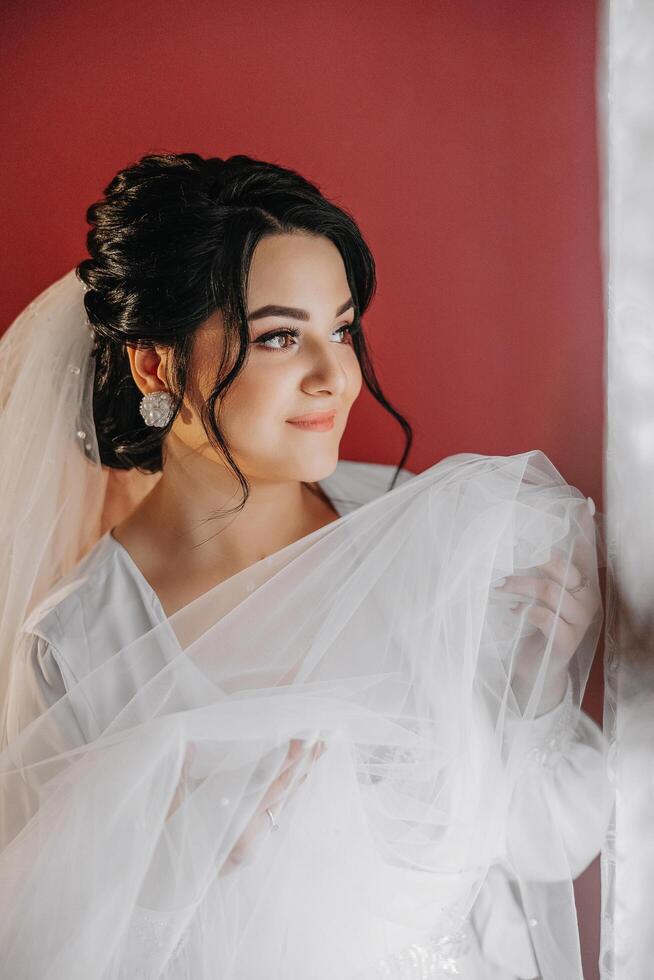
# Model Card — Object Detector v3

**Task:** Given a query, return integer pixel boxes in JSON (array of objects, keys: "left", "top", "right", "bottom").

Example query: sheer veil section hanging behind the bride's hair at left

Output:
[{"left": 0, "top": 269, "right": 159, "bottom": 730}]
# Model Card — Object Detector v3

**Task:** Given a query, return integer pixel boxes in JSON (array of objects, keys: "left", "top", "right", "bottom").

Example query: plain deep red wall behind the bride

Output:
[{"left": 0, "top": 0, "right": 603, "bottom": 980}]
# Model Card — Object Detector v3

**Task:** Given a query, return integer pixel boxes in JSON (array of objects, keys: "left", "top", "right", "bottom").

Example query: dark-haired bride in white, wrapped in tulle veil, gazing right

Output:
[{"left": 0, "top": 153, "right": 609, "bottom": 980}]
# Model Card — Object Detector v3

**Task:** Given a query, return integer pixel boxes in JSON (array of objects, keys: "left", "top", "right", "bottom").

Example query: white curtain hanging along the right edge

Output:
[{"left": 598, "top": 0, "right": 654, "bottom": 980}]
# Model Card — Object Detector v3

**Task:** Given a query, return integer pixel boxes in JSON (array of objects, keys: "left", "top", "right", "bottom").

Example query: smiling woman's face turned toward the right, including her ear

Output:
[{"left": 172, "top": 233, "right": 362, "bottom": 482}]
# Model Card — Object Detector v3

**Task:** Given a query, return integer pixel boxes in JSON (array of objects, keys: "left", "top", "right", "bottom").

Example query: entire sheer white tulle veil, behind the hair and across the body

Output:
[{"left": 0, "top": 273, "right": 610, "bottom": 980}]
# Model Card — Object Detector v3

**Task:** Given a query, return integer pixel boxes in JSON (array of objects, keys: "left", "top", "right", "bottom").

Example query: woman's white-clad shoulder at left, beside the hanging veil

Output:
[{"left": 21, "top": 533, "right": 160, "bottom": 686}]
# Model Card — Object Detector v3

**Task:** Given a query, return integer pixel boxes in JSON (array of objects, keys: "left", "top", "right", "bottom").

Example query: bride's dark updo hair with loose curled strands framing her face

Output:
[{"left": 76, "top": 153, "right": 413, "bottom": 513}]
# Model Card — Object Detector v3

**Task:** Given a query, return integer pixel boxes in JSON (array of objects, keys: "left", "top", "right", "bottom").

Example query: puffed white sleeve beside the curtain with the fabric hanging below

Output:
[{"left": 472, "top": 683, "right": 611, "bottom": 980}]
